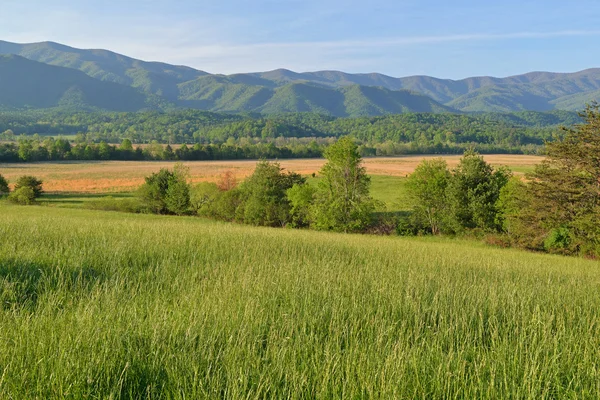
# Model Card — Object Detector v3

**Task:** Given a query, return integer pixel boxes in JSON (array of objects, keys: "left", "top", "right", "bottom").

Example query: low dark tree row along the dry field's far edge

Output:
[{"left": 0, "top": 135, "right": 536, "bottom": 163}]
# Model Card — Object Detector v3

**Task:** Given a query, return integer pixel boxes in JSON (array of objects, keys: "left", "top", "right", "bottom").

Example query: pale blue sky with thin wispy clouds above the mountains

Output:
[{"left": 0, "top": 0, "right": 600, "bottom": 79}]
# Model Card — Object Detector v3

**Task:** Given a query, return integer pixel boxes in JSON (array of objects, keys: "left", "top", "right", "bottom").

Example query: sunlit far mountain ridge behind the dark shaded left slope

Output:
[{"left": 0, "top": 41, "right": 600, "bottom": 116}]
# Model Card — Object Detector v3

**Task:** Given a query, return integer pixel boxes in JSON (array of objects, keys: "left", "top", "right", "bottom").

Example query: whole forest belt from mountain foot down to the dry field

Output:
[{"left": 0, "top": 110, "right": 580, "bottom": 162}]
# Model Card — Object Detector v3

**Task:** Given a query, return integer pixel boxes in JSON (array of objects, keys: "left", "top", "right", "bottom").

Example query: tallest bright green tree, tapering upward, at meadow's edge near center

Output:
[{"left": 312, "top": 137, "right": 375, "bottom": 232}]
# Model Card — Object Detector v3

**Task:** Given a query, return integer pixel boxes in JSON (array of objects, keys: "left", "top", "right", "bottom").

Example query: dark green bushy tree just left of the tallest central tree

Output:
[{"left": 239, "top": 161, "right": 305, "bottom": 226}]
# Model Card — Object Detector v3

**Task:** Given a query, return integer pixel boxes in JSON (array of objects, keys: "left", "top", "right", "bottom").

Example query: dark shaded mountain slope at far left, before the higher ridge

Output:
[{"left": 0, "top": 55, "right": 157, "bottom": 111}]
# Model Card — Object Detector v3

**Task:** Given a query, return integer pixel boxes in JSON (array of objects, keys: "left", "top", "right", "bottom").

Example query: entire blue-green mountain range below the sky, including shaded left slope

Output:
[{"left": 0, "top": 41, "right": 600, "bottom": 116}]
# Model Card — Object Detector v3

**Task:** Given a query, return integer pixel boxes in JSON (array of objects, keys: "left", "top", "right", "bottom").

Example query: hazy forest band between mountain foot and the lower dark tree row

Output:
[{"left": 0, "top": 110, "right": 579, "bottom": 153}]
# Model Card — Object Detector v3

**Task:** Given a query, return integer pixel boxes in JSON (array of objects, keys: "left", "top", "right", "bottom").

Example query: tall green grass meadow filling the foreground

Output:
[{"left": 0, "top": 202, "right": 600, "bottom": 399}]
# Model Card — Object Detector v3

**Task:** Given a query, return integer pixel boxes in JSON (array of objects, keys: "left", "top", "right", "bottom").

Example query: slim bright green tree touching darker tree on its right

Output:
[{"left": 407, "top": 158, "right": 451, "bottom": 235}]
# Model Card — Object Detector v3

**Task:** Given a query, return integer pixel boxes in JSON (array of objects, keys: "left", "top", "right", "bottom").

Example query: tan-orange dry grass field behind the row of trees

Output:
[{"left": 0, "top": 154, "right": 543, "bottom": 193}]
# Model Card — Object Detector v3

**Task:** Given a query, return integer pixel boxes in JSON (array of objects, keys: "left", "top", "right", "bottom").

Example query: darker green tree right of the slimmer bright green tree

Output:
[{"left": 446, "top": 151, "right": 511, "bottom": 232}]
